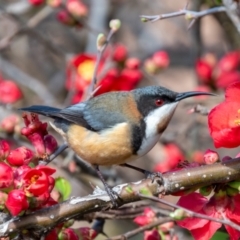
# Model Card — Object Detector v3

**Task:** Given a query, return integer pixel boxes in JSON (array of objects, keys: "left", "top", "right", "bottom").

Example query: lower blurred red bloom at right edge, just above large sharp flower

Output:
[{"left": 216, "top": 71, "right": 240, "bottom": 88}]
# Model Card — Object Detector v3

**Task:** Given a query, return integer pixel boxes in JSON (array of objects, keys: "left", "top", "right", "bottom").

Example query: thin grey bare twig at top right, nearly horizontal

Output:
[{"left": 140, "top": 6, "right": 226, "bottom": 24}]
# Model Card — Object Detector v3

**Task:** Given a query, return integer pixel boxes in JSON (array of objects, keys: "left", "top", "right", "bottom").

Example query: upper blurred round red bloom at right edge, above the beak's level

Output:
[{"left": 218, "top": 51, "right": 240, "bottom": 72}]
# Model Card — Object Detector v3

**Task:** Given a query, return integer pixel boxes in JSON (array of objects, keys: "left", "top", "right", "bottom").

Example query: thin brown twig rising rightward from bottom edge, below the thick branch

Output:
[{"left": 107, "top": 217, "right": 173, "bottom": 240}]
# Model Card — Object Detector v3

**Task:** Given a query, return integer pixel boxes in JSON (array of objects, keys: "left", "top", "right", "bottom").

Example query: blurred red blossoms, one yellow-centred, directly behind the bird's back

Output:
[{"left": 66, "top": 44, "right": 146, "bottom": 103}]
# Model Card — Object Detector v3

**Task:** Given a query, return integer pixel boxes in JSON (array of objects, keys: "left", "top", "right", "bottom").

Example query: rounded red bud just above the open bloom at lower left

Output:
[{"left": 7, "top": 147, "right": 34, "bottom": 166}]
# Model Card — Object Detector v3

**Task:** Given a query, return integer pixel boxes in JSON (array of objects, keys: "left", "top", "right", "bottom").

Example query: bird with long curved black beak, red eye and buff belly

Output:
[{"left": 20, "top": 86, "right": 214, "bottom": 206}]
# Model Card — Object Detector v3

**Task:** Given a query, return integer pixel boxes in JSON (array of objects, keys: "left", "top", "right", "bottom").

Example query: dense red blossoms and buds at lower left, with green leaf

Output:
[{"left": 0, "top": 114, "right": 98, "bottom": 240}]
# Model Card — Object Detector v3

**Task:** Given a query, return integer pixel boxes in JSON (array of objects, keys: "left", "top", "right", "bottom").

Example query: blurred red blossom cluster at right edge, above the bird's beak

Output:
[{"left": 196, "top": 50, "right": 240, "bottom": 90}]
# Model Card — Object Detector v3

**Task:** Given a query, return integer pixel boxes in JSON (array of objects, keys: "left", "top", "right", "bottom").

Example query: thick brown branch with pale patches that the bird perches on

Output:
[{"left": 0, "top": 158, "right": 240, "bottom": 237}]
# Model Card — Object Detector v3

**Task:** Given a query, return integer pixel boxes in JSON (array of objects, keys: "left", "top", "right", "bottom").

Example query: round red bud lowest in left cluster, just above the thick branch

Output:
[{"left": 5, "top": 189, "right": 29, "bottom": 216}]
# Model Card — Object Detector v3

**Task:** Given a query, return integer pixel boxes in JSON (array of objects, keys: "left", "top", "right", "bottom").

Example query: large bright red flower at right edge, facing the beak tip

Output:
[{"left": 208, "top": 82, "right": 240, "bottom": 148}]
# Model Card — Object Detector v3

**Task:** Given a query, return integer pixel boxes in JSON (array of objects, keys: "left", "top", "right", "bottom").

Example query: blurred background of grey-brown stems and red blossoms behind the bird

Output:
[{"left": 0, "top": 0, "right": 240, "bottom": 239}]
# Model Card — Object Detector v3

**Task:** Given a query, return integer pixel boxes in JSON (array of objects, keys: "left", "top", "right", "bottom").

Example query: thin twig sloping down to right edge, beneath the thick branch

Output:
[{"left": 138, "top": 194, "right": 240, "bottom": 231}]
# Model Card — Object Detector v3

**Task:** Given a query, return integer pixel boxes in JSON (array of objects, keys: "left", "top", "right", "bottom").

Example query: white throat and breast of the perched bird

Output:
[{"left": 137, "top": 102, "right": 178, "bottom": 156}]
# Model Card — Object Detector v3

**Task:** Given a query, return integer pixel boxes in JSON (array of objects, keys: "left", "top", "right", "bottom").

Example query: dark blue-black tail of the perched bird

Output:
[{"left": 19, "top": 105, "right": 61, "bottom": 117}]
